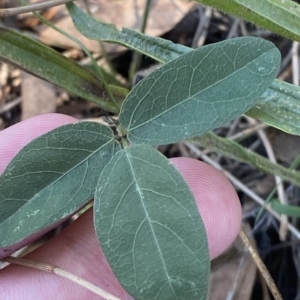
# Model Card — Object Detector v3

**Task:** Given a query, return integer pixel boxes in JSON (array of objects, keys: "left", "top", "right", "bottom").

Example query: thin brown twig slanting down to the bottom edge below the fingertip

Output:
[{"left": 239, "top": 229, "right": 283, "bottom": 300}]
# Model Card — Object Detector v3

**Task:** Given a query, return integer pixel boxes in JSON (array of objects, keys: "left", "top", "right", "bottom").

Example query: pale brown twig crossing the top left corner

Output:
[{"left": 0, "top": 0, "right": 74, "bottom": 18}]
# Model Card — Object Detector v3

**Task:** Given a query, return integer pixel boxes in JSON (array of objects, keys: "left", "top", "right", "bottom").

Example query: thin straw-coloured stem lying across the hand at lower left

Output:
[{"left": 2, "top": 256, "right": 120, "bottom": 300}]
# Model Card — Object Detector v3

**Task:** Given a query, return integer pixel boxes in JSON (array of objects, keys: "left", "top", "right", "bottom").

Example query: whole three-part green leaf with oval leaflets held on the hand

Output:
[{"left": 0, "top": 16, "right": 280, "bottom": 300}]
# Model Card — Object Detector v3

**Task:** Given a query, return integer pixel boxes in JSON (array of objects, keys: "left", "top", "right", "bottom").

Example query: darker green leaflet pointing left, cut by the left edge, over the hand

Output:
[{"left": 0, "top": 122, "right": 120, "bottom": 258}]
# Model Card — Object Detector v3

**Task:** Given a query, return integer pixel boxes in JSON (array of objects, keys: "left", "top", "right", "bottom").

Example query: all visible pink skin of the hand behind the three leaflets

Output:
[{"left": 0, "top": 114, "right": 242, "bottom": 300}]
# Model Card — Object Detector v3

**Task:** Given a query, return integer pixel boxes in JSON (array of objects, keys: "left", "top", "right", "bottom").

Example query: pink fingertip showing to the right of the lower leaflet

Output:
[{"left": 171, "top": 157, "right": 242, "bottom": 259}]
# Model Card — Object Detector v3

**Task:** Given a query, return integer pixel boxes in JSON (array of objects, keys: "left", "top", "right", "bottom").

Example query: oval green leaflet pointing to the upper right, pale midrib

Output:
[{"left": 120, "top": 37, "right": 280, "bottom": 145}]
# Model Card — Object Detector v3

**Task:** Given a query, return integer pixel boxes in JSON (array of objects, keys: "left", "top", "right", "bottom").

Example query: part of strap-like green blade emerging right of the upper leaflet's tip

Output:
[{"left": 246, "top": 80, "right": 300, "bottom": 135}]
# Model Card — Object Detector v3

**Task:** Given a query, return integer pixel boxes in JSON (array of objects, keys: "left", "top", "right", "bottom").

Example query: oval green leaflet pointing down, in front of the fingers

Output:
[{"left": 94, "top": 145, "right": 210, "bottom": 300}]
